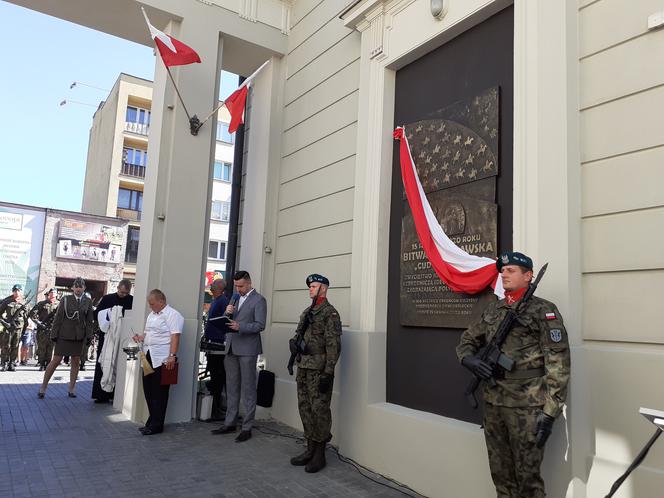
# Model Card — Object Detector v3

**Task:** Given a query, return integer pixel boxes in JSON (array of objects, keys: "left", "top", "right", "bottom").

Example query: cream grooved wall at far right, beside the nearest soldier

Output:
[{"left": 578, "top": 0, "right": 664, "bottom": 497}]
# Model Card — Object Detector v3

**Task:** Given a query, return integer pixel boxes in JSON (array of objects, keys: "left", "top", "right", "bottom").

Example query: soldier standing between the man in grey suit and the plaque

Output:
[{"left": 291, "top": 273, "right": 341, "bottom": 473}]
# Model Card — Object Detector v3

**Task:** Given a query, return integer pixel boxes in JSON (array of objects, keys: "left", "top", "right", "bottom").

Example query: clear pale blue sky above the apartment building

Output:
[{"left": 0, "top": 0, "right": 237, "bottom": 211}]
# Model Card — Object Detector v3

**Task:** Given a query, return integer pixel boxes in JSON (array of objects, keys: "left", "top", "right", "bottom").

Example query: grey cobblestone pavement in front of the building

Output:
[{"left": 0, "top": 362, "right": 416, "bottom": 498}]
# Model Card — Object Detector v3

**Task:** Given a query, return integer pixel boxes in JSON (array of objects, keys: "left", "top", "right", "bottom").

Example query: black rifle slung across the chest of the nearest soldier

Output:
[{"left": 465, "top": 263, "right": 549, "bottom": 408}]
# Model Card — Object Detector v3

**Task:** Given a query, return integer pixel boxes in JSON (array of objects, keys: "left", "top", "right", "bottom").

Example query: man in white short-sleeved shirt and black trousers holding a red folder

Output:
[{"left": 134, "top": 289, "right": 184, "bottom": 436}]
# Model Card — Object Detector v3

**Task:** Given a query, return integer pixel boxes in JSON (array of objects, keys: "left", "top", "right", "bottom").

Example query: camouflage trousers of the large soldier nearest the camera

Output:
[{"left": 484, "top": 403, "right": 545, "bottom": 498}]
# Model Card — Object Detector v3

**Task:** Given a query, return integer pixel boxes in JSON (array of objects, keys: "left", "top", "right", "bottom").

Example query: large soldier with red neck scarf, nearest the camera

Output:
[{"left": 457, "top": 252, "right": 570, "bottom": 498}]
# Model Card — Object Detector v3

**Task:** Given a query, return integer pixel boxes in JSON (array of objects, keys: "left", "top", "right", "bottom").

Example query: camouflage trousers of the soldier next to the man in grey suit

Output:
[{"left": 296, "top": 367, "right": 332, "bottom": 443}]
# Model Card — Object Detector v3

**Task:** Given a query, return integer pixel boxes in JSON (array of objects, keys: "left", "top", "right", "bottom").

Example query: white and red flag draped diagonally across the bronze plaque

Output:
[{"left": 394, "top": 126, "right": 505, "bottom": 298}]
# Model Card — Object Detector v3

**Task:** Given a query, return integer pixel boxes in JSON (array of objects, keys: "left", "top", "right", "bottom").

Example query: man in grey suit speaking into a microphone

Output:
[{"left": 212, "top": 271, "right": 267, "bottom": 443}]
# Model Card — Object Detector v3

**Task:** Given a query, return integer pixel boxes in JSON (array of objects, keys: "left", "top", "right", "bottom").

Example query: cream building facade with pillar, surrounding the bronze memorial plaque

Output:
[{"left": 7, "top": 0, "right": 664, "bottom": 498}]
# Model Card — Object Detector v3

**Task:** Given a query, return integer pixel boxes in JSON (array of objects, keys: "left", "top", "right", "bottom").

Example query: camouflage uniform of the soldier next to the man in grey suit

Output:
[{"left": 295, "top": 300, "right": 341, "bottom": 443}]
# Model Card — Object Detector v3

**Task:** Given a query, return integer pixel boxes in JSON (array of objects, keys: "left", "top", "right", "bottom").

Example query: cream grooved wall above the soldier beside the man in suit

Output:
[{"left": 272, "top": 1, "right": 360, "bottom": 322}]
